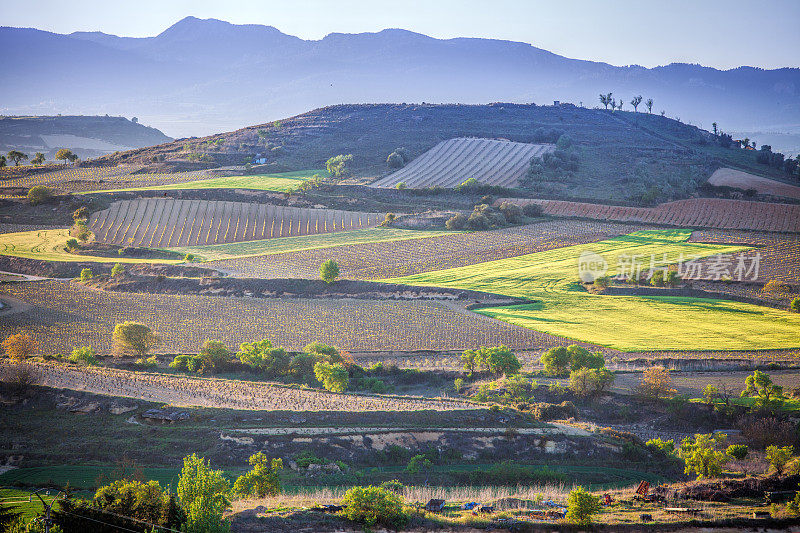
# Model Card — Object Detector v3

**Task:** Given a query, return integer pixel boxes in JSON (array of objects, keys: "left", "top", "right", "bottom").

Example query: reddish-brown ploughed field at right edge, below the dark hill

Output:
[{"left": 504, "top": 198, "right": 800, "bottom": 233}]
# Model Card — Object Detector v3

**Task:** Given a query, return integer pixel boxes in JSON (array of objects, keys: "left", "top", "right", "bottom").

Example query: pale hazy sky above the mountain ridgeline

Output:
[{"left": 0, "top": 0, "right": 800, "bottom": 68}]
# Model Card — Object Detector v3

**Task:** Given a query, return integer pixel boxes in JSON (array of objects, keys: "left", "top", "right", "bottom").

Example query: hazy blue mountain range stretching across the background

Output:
[{"left": 0, "top": 17, "right": 800, "bottom": 137}]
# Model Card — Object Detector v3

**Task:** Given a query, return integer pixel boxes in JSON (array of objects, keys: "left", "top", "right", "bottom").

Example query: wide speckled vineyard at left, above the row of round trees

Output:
[{"left": 0, "top": 281, "right": 559, "bottom": 353}]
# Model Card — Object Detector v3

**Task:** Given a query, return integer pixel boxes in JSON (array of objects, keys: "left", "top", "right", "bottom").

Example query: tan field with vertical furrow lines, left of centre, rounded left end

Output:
[{"left": 89, "top": 198, "right": 383, "bottom": 248}]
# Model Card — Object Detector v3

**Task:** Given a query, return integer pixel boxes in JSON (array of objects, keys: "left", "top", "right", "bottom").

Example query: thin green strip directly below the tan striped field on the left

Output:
[{"left": 167, "top": 228, "right": 458, "bottom": 261}]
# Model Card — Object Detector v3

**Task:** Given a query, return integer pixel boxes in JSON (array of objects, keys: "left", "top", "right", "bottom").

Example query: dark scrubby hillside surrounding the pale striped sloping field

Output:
[{"left": 97, "top": 103, "right": 792, "bottom": 204}]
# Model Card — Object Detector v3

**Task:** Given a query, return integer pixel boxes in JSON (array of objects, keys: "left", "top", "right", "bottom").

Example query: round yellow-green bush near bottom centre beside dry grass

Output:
[{"left": 341, "top": 486, "right": 408, "bottom": 529}]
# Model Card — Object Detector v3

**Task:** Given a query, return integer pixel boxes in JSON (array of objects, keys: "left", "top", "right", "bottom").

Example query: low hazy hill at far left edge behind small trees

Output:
[{"left": 0, "top": 116, "right": 172, "bottom": 159}]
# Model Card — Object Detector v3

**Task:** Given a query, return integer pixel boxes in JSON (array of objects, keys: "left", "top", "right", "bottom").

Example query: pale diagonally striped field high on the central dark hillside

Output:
[{"left": 372, "top": 137, "right": 553, "bottom": 189}]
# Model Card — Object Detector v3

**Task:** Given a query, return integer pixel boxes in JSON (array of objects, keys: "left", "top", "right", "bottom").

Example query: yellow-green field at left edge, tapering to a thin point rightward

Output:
[{"left": 0, "top": 229, "right": 180, "bottom": 264}]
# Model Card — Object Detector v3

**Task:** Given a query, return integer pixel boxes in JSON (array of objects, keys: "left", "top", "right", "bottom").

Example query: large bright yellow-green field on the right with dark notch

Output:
[{"left": 387, "top": 230, "right": 800, "bottom": 351}]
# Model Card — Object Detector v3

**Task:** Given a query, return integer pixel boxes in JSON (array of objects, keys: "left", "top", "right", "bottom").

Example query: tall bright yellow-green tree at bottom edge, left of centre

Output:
[{"left": 177, "top": 454, "right": 231, "bottom": 533}]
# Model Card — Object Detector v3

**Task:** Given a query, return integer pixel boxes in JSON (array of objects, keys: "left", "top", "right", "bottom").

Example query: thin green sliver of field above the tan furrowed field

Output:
[{"left": 80, "top": 170, "right": 329, "bottom": 194}]
